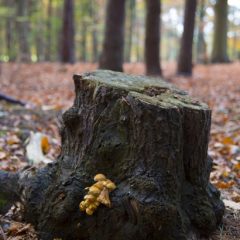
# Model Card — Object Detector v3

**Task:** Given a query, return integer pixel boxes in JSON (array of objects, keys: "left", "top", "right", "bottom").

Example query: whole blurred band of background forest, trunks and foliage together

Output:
[{"left": 0, "top": 0, "right": 240, "bottom": 75}]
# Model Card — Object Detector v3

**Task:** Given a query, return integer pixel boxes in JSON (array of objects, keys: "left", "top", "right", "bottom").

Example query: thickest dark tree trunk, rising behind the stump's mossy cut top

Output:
[{"left": 99, "top": 0, "right": 125, "bottom": 72}]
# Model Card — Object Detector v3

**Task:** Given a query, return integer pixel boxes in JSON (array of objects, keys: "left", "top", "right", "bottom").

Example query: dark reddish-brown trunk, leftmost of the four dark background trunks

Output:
[{"left": 61, "top": 0, "right": 75, "bottom": 63}]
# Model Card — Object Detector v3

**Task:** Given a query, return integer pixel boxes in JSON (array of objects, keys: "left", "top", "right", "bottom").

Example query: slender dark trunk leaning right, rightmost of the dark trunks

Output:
[{"left": 177, "top": 0, "right": 197, "bottom": 75}]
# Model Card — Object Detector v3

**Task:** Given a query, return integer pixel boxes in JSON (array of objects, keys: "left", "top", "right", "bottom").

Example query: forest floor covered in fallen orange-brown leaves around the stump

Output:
[{"left": 0, "top": 63, "right": 240, "bottom": 240}]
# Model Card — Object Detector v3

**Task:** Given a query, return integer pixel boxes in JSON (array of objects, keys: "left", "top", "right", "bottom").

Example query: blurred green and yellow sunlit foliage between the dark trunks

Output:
[{"left": 0, "top": 0, "right": 240, "bottom": 63}]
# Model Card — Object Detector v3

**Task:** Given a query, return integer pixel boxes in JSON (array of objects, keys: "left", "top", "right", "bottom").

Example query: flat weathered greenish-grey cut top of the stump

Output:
[{"left": 73, "top": 70, "right": 209, "bottom": 110}]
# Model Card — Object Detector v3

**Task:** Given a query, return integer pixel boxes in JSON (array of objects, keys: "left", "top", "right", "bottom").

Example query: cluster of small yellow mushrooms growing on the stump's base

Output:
[{"left": 79, "top": 173, "right": 116, "bottom": 215}]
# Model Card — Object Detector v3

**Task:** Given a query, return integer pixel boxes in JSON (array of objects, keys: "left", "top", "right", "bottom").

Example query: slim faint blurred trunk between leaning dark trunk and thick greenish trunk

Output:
[{"left": 197, "top": 0, "right": 208, "bottom": 63}]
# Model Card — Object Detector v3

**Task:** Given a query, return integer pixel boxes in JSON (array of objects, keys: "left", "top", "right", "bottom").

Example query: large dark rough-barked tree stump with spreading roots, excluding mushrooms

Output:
[{"left": 0, "top": 70, "right": 224, "bottom": 240}]
